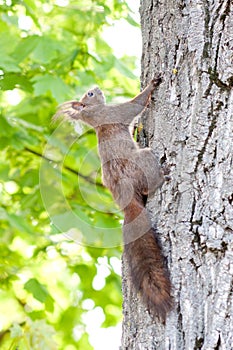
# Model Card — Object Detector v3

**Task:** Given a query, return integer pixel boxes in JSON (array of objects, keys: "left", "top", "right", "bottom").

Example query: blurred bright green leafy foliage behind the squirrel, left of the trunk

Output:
[{"left": 0, "top": 0, "right": 138, "bottom": 350}]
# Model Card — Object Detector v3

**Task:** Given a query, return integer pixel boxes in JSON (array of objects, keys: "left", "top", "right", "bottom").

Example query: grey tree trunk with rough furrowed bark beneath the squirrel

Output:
[{"left": 122, "top": 0, "right": 233, "bottom": 350}]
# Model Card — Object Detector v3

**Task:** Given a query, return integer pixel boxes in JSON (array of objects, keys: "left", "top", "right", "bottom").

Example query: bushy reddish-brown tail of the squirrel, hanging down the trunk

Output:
[{"left": 123, "top": 199, "right": 172, "bottom": 321}]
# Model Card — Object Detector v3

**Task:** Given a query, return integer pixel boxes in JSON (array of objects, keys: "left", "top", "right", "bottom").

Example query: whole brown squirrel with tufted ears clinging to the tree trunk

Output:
[{"left": 54, "top": 76, "right": 172, "bottom": 321}]
